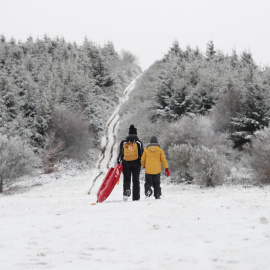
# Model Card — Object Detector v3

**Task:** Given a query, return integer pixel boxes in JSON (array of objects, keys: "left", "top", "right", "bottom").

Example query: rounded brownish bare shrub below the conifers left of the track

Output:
[{"left": 49, "top": 109, "right": 93, "bottom": 160}]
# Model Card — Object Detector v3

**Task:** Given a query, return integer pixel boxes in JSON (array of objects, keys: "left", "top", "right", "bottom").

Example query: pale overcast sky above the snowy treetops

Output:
[{"left": 0, "top": 0, "right": 270, "bottom": 69}]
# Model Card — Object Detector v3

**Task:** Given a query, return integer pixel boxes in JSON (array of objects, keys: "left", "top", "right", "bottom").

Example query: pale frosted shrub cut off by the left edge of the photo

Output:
[{"left": 0, "top": 136, "right": 40, "bottom": 193}]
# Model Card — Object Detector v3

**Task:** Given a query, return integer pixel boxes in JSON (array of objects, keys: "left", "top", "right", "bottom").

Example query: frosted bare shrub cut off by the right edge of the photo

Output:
[{"left": 246, "top": 127, "right": 270, "bottom": 184}]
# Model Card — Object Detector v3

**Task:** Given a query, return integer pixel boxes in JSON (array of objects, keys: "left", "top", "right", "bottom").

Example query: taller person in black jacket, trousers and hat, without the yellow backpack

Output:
[{"left": 117, "top": 125, "right": 143, "bottom": 201}]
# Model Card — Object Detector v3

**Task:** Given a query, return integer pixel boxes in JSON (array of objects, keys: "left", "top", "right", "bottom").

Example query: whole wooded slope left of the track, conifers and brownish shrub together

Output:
[{"left": 0, "top": 35, "right": 141, "bottom": 192}]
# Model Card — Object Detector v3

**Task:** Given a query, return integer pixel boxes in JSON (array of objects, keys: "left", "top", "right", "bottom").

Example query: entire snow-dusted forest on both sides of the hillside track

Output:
[{"left": 0, "top": 36, "right": 270, "bottom": 191}]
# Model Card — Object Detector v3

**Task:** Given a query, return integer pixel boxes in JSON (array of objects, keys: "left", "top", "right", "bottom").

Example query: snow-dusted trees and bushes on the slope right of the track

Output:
[{"left": 119, "top": 41, "right": 270, "bottom": 184}]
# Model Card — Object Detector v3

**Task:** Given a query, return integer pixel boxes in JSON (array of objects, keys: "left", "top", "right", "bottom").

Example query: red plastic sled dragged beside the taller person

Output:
[{"left": 97, "top": 164, "right": 123, "bottom": 203}]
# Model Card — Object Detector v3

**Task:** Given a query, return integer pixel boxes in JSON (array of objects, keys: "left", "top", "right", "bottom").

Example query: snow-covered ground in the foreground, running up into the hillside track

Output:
[{"left": 0, "top": 79, "right": 270, "bottom": 270}]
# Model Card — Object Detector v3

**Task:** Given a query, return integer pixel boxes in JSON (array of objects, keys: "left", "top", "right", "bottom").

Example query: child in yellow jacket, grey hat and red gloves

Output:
[{"left": 141, "top": 135, "right": 170, "bottom": 199}]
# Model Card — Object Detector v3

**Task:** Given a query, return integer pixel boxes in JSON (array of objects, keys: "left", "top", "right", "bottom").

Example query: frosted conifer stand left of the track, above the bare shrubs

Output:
[{"left": 0, "top": 36, "right": 140, "bottom": 150}]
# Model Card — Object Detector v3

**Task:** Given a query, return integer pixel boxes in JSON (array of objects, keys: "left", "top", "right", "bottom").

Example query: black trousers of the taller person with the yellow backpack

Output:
[{"left": 122, "top": 159, "right": 141, "bottom": 201}]
